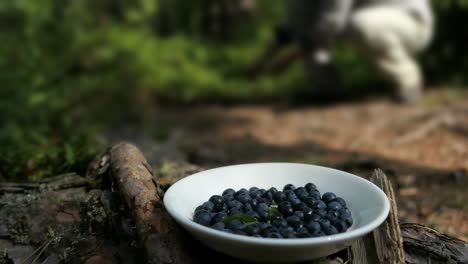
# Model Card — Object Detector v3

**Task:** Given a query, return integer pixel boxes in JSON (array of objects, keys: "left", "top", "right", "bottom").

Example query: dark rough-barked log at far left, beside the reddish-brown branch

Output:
[{"left": 0, "top": 174, "right": 144, "bottom": 264}]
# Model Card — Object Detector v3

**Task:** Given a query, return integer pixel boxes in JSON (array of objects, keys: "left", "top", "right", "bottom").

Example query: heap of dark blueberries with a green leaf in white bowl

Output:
[{"left": 193, "top": 183, "right": 353, "bottom": 238}]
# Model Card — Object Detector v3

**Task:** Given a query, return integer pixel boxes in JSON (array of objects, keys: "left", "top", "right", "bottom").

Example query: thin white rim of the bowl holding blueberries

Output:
[{"left": 163, "top": 162, "right": 390, "bottom": 247}]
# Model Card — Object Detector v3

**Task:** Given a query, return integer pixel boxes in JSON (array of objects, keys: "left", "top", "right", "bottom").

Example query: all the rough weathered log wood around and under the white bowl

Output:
[{"left": 0, "top": 143, "right": 468, "bottom": 264}]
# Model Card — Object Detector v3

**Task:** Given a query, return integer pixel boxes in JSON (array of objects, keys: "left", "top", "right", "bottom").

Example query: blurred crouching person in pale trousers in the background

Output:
[{"left": 249, "top": 0, "right": 434, "bottom": 103}]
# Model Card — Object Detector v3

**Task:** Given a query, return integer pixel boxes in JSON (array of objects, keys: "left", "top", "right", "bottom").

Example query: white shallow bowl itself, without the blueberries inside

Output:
[{"left": 164, "top": 163, "right": 390, "bottom": 262}]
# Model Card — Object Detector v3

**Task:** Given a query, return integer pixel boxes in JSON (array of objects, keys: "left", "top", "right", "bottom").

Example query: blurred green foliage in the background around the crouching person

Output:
[{"left": 0, "top": 0, "right": 468, "bottom": 179}]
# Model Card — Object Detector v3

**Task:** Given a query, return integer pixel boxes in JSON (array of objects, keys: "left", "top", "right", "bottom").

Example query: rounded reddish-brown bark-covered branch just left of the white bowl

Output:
[{"left": 88, "top": 143, "right": 193, "bottom": 264}]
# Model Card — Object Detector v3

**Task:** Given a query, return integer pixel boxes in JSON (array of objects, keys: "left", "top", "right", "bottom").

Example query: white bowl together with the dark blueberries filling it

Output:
[{"left": 164, "top": 163, "right": 390, "bottom": 263}]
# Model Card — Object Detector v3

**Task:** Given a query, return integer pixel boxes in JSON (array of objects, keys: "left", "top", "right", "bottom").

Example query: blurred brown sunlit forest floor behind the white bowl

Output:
[{"left": 106, "top": 89, "right": 468, "bottom": 240}]
